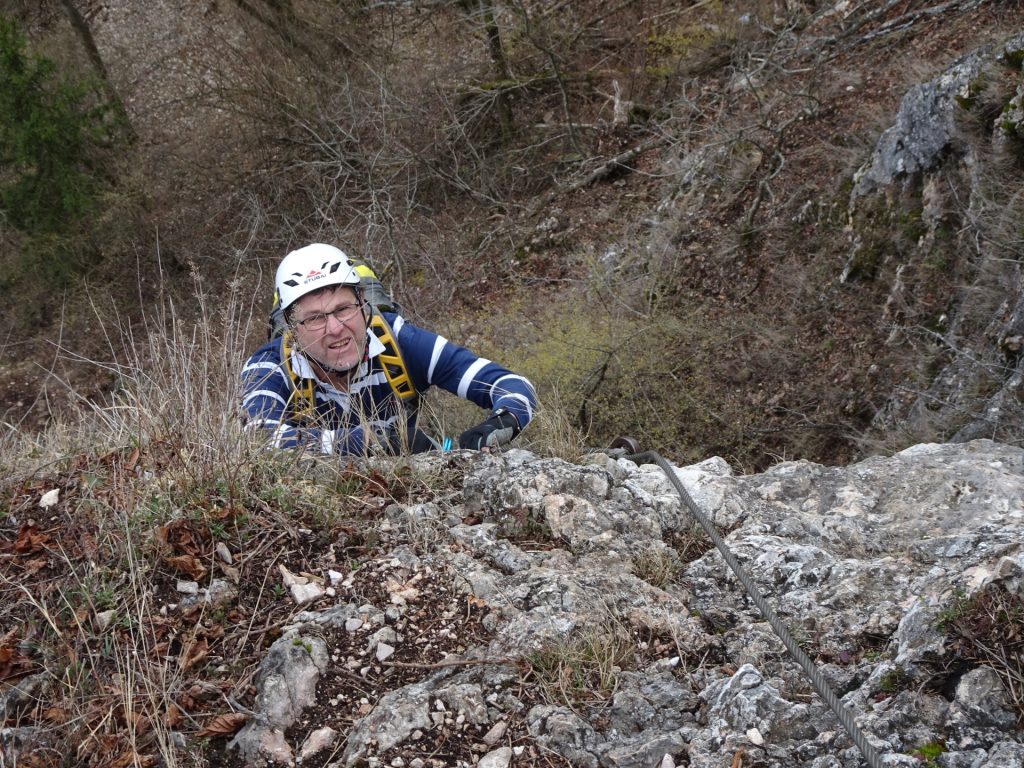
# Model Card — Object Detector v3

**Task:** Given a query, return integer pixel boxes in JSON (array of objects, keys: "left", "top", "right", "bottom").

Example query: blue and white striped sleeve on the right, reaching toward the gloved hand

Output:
[{"left": 388, "top": 315, "right": 537, "bottom": 429}]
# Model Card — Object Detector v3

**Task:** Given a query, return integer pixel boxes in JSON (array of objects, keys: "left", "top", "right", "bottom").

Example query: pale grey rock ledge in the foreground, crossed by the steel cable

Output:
[{"left": 236, "top": 440, "right": 1024, "bottom": 768}]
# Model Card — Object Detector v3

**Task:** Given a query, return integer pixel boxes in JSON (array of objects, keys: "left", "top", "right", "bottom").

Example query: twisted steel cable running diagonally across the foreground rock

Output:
[{"left": 624, "top": 451, "right": 882, "bottom": 768}]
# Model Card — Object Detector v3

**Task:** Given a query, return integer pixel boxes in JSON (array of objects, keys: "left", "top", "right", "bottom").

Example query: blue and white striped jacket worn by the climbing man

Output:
[{"left": 242, "top": 312, "right": 537, "bottom": 455}]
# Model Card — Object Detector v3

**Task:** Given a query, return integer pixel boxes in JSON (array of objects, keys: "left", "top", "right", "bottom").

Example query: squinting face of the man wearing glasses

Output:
[{"left": 292, "top": 287, "right": 367, "bottom": 371}]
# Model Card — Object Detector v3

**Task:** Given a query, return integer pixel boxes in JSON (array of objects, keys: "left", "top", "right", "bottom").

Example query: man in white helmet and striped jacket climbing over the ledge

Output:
[{"left": 242, "top": 243, "right": 537, "bottom": 455}]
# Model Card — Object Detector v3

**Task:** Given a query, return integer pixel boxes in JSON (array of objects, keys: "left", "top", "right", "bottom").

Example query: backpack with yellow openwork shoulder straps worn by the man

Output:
[{"left": 267, "top": 259, "right": 419, "bottom": 420}]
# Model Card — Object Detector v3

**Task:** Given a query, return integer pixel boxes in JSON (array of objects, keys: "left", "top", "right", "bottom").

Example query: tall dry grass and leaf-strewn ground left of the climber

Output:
[{"left": 0, "top": 264, "right": 285, "bottom": 766}]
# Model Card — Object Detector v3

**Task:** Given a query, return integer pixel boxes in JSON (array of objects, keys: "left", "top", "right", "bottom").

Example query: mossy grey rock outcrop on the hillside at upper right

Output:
[{"left": 840, "top": 34, "right": 1024, "bottom": 450}]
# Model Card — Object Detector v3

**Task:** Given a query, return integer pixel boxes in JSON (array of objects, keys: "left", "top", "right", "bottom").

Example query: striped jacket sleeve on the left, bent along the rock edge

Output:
[{"left": 242, "top": 347, "right": 367, "bottom": 455}]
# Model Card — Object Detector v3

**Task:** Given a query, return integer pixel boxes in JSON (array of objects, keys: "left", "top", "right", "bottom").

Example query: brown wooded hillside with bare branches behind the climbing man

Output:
[{"left": 0, "top": 0, "right": 1024, "bottom": 470}]
